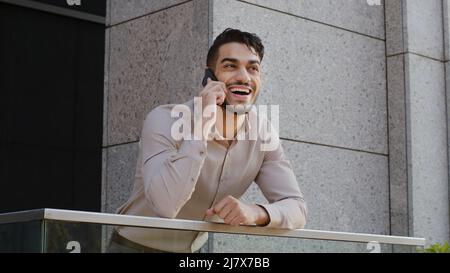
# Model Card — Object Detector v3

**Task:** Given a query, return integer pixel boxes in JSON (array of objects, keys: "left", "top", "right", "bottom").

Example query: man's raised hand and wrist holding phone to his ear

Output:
[{"left": 199, "top": 78, "right": 227, "bottom": 132}]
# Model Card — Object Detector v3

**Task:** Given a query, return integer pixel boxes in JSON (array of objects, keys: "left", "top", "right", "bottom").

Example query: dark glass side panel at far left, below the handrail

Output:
[{"left": 0, "top": 221, "right": 42, "bottom": 253}]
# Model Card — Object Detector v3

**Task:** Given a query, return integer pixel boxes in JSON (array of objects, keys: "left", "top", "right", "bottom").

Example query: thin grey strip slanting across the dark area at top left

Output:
[{"left": 0, "top": 0, "right": 106, "bottom": 25}]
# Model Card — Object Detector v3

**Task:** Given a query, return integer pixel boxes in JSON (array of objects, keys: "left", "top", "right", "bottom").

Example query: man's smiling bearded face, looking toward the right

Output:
[{"left": 214, "top": 42, "right": 261, "bottom": 105}]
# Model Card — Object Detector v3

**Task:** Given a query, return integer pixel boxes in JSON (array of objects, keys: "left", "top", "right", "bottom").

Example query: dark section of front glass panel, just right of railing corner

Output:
[{"left": 44, "top": 220, "right": 102, "bottom": 253}]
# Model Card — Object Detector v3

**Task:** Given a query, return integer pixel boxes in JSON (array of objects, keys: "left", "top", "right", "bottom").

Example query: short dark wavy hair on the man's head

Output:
[{"left": 206, "top": 28, "right": 264, "bottom": 69}]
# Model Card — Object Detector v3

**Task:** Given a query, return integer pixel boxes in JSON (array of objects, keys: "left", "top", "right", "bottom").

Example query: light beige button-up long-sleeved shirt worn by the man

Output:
[{"left": 117, "top": 100, "right": 306, "bottom": 252}]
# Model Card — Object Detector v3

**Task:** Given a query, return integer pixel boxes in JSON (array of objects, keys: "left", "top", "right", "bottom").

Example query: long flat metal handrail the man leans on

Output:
[{"left": 0, "top": 208, "right": 426, "bottom": 246}]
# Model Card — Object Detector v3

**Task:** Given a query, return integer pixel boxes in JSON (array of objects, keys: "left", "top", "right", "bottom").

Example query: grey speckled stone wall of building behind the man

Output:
[{"left": 1, "top": 0, "right": 450, "bottom": 251}]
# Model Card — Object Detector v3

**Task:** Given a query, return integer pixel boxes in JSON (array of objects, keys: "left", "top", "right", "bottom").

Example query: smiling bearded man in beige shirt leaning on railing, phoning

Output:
[{"left": 109, "top": 29, "right": 306, "bottom": 252}]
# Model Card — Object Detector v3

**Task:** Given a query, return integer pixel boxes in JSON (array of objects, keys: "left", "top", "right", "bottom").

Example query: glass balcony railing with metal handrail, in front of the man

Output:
[{"left": 0, "top": 209, "right": 425, "bottom": 253}]
